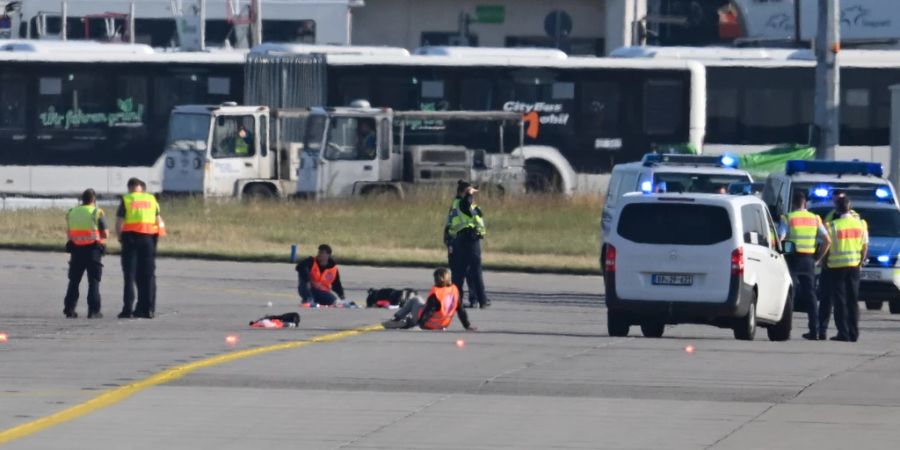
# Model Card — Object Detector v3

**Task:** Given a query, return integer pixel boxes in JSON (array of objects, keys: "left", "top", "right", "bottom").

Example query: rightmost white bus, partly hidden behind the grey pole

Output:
[{"left": 612, "top": 47, "right": 900, "bottom": 164}]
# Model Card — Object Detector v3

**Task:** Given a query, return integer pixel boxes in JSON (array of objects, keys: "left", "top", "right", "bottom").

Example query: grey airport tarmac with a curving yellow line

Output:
[{"left": 0, "top": 249, "right": 900, "bottom": 450}]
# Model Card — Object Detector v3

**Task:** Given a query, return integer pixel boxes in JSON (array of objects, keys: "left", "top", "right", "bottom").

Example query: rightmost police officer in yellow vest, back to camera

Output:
[{"left": 819, "top": 196, "right": 869, "bottom": 342}]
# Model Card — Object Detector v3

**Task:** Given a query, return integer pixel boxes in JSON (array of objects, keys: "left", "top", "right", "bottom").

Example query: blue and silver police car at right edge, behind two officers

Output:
[{"left": 809, "top": 192, "right": 900, "bottom": 314}]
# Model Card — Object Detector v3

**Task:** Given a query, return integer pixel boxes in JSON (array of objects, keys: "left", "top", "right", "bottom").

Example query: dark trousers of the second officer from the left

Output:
[{"left": 122, "top": 232, "right": 157, "bottom": 317}]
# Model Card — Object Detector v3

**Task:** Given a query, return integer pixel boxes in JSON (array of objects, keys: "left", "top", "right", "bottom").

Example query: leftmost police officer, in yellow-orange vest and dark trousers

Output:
[{"left": 63, "top": 189, "right": 109, "bottom": 319}]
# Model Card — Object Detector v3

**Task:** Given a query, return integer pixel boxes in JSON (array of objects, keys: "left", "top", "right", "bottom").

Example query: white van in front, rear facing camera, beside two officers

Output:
[{"left": 604, "top": 193, "right": 793, "bottom": 341}]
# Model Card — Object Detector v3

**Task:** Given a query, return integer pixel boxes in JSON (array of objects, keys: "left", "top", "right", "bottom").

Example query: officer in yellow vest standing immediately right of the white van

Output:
[{"left": 781, "top": 191, "right": 831, "bottom": 341}]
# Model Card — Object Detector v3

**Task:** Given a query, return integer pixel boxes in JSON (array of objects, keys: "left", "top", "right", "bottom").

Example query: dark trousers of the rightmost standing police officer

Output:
[{"left": 819, "top": 267, "right": 859, "bottom": 341}]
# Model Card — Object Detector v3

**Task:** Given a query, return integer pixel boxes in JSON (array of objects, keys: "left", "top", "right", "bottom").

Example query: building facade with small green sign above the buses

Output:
[{"left": 352, "top": 0, "right": 646, "bottom": 55}]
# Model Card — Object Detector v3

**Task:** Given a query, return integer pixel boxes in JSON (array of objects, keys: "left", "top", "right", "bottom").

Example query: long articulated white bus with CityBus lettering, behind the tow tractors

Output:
[{"left": 0, "top": 41, "right": 706, "bottom": 195}]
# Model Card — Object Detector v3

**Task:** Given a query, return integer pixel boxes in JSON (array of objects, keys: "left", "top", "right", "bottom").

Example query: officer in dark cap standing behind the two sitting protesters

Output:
[{"left": 447, "top": 182, "right": 491, "bottom": 312}]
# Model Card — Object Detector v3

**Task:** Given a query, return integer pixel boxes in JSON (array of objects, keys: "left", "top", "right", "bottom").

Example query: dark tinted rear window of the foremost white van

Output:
[{"left": 616, "top": 203, "right": 731, "bottom": 245}]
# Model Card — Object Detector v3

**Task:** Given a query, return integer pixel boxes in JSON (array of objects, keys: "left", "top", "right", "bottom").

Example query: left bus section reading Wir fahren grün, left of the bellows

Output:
[{"left": 0, "top": 41, "right": 245, "bottom": 195}]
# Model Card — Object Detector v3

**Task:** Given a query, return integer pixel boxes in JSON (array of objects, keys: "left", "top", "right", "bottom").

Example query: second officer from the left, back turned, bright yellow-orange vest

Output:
[{"left": 116, "top": 178, "right": 165, "bottom": 319}]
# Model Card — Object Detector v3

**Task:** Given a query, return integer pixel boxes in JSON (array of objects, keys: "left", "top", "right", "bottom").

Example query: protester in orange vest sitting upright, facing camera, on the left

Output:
[{"left": 296, "top": 244, "right": 345, "bottom": 306}]
